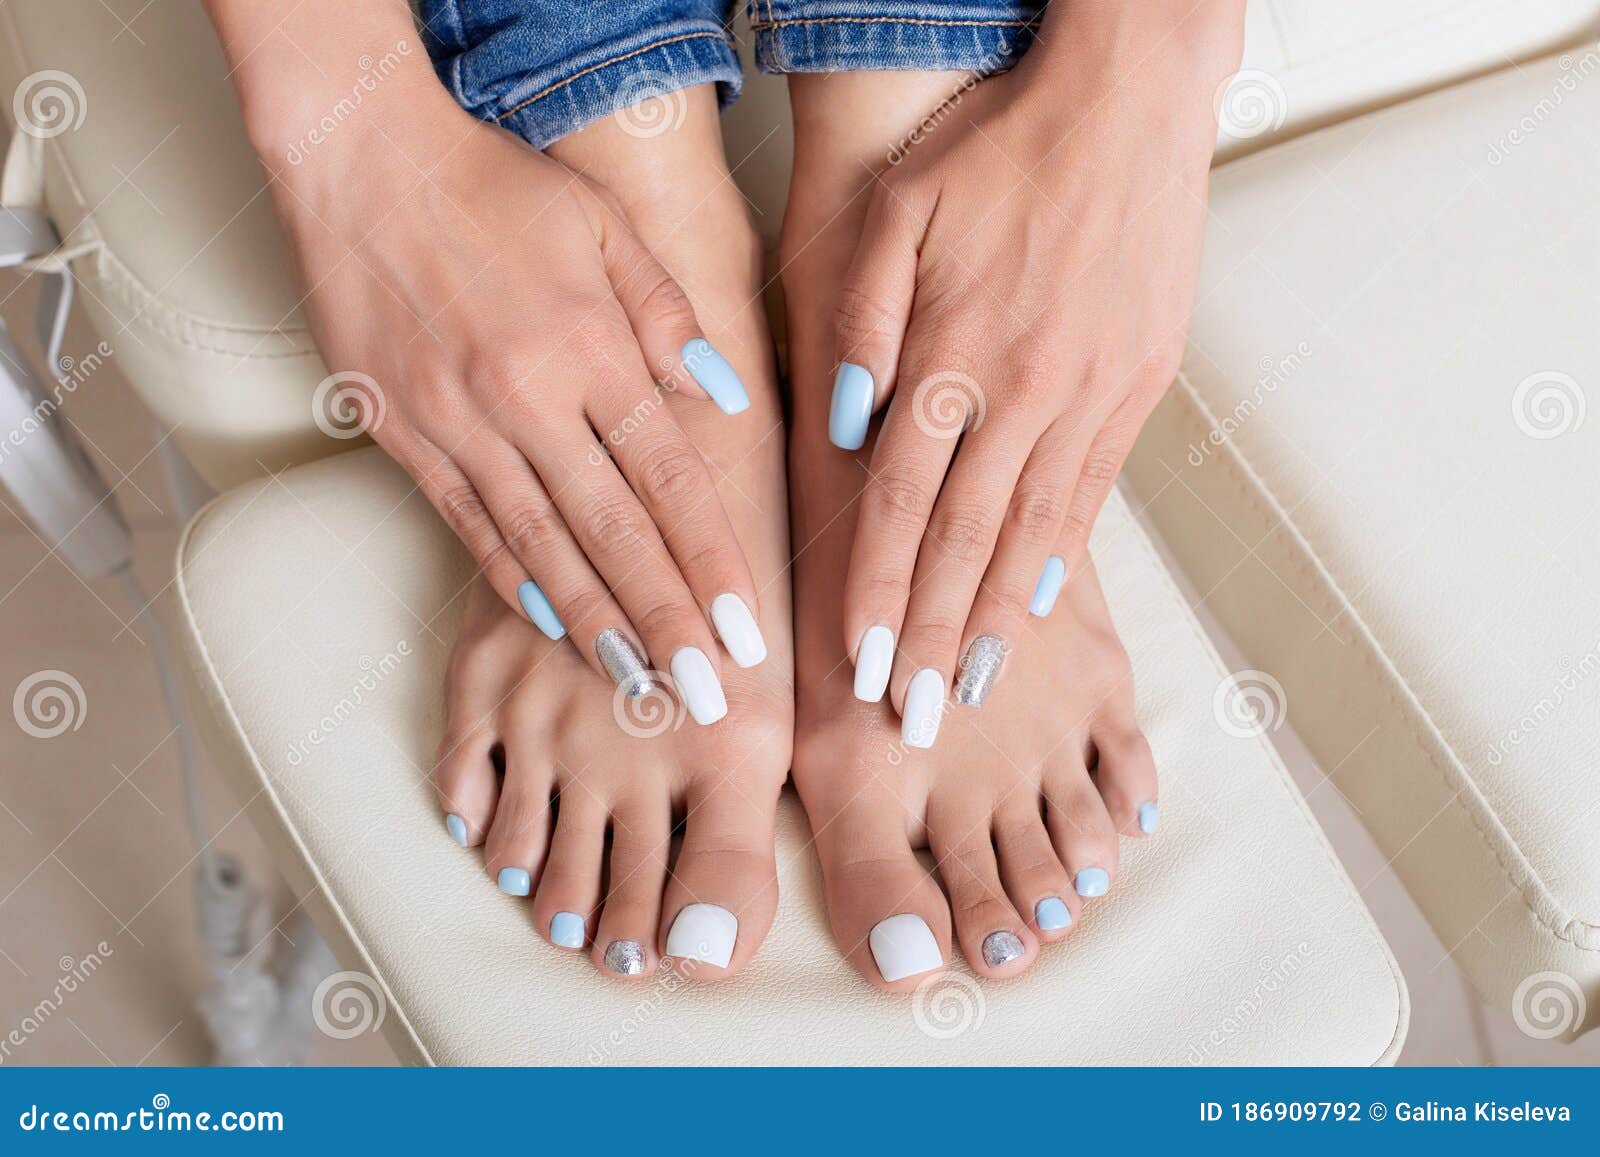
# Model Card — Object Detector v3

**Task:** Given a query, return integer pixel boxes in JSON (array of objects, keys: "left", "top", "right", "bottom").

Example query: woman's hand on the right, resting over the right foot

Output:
[{"left": 829, "top": 0, "right": 1243, "bottom": 714}]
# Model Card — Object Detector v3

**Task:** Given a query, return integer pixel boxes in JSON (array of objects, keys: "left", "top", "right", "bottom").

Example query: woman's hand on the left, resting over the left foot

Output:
[{"left": 213, "top": 0, "right": 762, "bottom": 710}]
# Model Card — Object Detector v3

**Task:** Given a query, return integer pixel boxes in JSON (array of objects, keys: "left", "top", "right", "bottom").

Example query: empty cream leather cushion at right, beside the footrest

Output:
[{"left": 1130, "top": 48, "right": 1600, "bottom": 1032}]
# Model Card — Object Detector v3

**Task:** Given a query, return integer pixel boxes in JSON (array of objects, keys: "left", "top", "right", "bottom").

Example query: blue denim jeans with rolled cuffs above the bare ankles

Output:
[{"left": 416, "top": 0, "right": 1045, "bottom": 149}]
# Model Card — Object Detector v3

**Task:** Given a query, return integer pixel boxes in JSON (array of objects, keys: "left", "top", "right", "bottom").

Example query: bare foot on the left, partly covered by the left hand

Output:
[{"left": 435, "top": 90, "right": 794, "bottom": 979}]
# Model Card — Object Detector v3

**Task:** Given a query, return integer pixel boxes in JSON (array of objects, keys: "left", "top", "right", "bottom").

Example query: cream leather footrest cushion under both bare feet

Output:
[{"left": 178, "top": 450, "right": 1406, "bottom": 1064}]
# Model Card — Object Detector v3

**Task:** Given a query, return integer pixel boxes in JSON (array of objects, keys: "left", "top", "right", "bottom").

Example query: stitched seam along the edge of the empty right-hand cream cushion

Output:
[{"left": 1176, "top": 373, "right": 1600, "bottom": 952}]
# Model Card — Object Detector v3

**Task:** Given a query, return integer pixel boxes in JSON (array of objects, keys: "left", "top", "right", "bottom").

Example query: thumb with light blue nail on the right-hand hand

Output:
[{"left": 827, "top": 181, "right": 926, "bottom": 450}]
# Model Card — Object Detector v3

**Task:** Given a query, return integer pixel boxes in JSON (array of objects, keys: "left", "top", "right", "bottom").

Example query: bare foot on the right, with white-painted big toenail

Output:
[{"left": 782, "top": 74, "right": 1158, "bottom": 991}]
